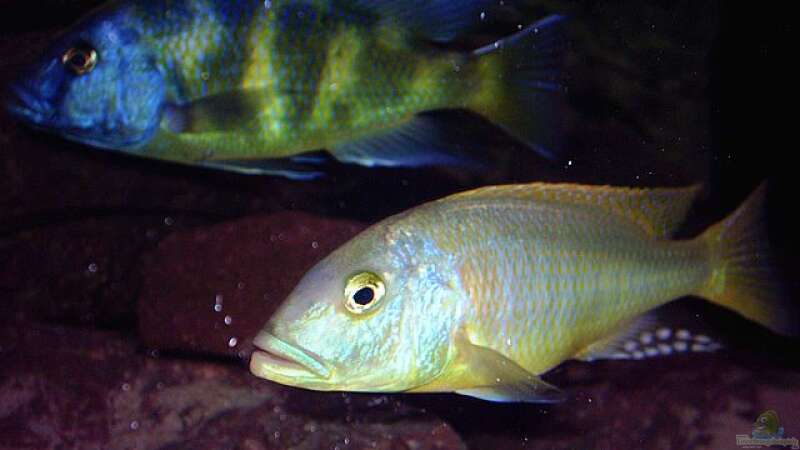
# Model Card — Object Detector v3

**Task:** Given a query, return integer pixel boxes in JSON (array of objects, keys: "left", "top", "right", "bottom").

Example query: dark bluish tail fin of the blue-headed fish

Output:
[{"left": 473, "top": 15, "right": 566, "bottom": 159}]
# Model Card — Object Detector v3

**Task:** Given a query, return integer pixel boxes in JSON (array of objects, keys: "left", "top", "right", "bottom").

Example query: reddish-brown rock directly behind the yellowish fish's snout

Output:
[{"left": 138, "top": 212, "right": 364, "bottom": 356}]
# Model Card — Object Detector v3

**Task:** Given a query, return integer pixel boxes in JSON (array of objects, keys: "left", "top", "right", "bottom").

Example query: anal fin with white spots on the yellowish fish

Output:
[{"left": 575, "top": 313, "right": 722, "bottom": 361}]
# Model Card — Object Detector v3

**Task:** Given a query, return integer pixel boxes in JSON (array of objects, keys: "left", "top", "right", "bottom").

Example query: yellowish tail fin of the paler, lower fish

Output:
[{"left": 699, "top": 183, "right": 800, "bottom": 336}]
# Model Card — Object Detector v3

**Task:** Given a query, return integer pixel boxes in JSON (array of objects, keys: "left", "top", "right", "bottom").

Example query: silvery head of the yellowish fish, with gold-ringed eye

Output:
[{"left": 250, "top": 224, "right": 460, "bottom": 392}]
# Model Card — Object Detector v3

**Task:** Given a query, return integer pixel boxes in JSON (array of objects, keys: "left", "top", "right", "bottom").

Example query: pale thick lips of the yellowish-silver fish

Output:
[{"left": 250, "top": 331, "right": 331, "bottom": 382}]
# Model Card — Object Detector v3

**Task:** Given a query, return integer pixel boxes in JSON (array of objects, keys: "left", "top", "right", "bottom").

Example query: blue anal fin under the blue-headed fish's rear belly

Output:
[{"left": 331, "top": 116, "right": 479, "bottom": 167}]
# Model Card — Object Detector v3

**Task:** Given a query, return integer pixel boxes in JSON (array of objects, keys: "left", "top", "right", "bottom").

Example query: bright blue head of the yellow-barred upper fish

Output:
[{"left": 6, "top": 7, "right": 165, "bottom": 150}]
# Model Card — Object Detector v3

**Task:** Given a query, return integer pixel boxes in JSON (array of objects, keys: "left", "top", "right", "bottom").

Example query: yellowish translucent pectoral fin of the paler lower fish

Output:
[{"left": 455, "top": 337, "right": 566, "bottom": 403}]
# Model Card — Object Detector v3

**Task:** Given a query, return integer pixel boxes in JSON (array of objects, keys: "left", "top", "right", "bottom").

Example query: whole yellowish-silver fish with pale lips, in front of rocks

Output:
[{"left": 250, "top": 183, "right": 797, "bottom": 402}]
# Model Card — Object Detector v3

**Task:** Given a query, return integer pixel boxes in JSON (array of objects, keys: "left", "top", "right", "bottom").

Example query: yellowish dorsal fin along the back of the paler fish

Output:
[{"left": 443, "top": 183, "right": 700, "bottom": 238}]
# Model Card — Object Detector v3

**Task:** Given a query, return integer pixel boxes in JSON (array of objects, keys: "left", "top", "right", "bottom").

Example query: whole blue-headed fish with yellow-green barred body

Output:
[{"left": 9, "top": 0, "right": 563, "bottom": 178}]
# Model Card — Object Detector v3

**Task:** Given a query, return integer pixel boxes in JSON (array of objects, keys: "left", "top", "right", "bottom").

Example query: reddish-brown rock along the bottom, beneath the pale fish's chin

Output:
[{"left": 0, "top": 323, "right": 465, "bottom": 450}]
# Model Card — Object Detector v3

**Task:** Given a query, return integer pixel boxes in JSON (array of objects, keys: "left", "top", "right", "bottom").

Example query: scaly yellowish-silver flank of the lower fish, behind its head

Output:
[{"left": 420, "top": 199, "right": 710, "bottom": 374}]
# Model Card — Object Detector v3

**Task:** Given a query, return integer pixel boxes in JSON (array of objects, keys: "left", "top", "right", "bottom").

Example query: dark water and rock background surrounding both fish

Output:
[{"left": 0, "top": 0, "right": 800, "bottom": 449}]
